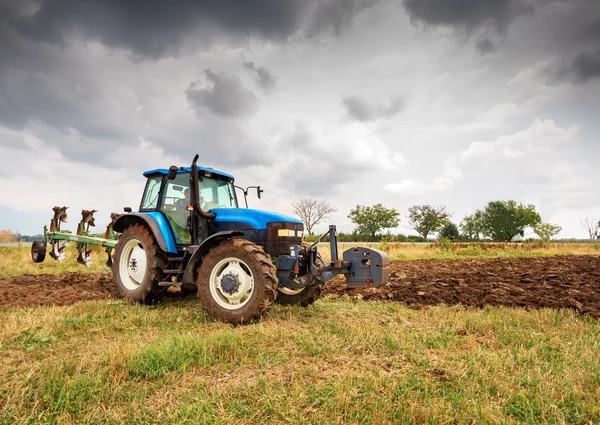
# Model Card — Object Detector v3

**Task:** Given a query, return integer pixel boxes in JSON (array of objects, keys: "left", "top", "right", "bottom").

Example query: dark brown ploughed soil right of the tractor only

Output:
[{"left": 326, "top": 256, "right": 600, "bottom": 317}]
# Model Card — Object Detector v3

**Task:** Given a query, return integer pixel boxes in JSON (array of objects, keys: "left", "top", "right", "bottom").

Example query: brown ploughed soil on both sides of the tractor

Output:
[{"left": 0, "top": 256, "right": 600, "bottom": 317}]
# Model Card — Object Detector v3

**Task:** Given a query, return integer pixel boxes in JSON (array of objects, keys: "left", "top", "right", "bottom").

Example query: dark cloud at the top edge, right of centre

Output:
[{"left": 404, "top": 0, "right": 534, "bottom": 34}]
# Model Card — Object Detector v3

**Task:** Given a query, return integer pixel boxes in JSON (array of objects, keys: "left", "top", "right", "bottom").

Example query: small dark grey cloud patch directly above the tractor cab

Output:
[{"left": 186, "top": 69, "right": 258, "bottom": 117}]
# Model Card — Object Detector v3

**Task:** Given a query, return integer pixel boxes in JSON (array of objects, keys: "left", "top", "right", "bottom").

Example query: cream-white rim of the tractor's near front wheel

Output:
[{"left": 209, "top": 257, "right": 254, "bottom": 310}]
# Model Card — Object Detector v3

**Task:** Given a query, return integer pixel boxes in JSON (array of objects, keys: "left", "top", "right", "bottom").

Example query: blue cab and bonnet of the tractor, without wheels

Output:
[{"left": 139, "top": 161, "right": 304, "bottom": 255}]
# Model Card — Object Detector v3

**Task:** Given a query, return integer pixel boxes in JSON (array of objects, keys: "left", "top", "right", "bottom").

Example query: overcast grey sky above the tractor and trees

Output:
[{"left": 0, "top": 0, "right": 600, "bottom": 237}]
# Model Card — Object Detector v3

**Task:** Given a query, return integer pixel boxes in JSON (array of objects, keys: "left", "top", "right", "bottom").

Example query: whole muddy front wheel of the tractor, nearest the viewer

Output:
[{"left": 196, "top": 239, "right": 277, "bottom": 325}]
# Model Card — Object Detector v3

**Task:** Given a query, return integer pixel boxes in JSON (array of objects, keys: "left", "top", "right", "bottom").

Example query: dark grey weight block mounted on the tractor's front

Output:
[{"left": 343, "top": 247, "right": 390, "bottom": 288}]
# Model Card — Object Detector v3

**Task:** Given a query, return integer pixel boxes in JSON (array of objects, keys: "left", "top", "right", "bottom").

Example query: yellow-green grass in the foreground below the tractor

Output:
[{"left": 0, "top": 297, "right": 600, "bottom": 424}]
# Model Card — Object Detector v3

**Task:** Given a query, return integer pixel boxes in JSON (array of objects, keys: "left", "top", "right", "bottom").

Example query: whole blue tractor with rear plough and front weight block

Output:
[{"left": 32, "top": 155, "right": 389, "bottom": 324}]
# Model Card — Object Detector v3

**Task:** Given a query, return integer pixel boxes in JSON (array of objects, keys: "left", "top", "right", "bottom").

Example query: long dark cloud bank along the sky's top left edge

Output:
[{"left": 0, "top": 0, "right": 379, "bottom": 59}]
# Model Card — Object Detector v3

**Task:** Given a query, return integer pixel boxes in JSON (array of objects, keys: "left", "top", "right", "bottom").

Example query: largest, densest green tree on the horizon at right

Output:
[{"left": 481, "top": 201, "right": 542, "bottom": 242}]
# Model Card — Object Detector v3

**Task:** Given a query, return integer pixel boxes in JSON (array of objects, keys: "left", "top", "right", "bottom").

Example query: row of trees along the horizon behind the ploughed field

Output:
[{"left": 292, "top": 199, "right": 600, "bottom": 242}]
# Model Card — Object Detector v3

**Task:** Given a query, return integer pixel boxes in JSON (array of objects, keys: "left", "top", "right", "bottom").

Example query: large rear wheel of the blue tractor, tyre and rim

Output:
[{"left": 112, "top": 224, "right": 167, "bottom": 304}]
